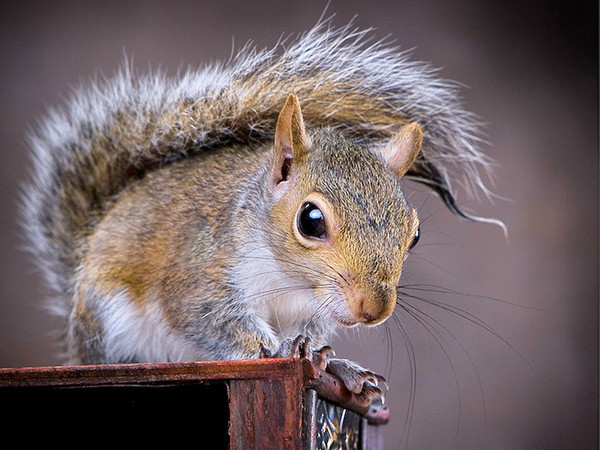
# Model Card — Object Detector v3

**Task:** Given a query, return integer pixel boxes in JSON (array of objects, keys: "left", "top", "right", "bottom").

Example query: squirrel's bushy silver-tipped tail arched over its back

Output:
[{"left": 24, "top": 22, "right": 500, "bottom": 302}]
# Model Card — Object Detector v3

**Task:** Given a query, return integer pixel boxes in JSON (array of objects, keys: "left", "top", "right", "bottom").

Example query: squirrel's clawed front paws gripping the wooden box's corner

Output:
[{"left": 260, "top": 335, "right": 386, "bottom": 401}]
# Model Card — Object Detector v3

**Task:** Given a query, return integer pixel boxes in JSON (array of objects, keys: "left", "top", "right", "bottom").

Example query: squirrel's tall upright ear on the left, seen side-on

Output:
[{"left": 273, "top": 94, "right": 306, "bottom": 185}]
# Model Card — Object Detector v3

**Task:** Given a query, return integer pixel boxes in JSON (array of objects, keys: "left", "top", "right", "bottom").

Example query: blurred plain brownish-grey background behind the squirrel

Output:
[{"left": 0, "top": 0, "right": 598, "bottom": 449}]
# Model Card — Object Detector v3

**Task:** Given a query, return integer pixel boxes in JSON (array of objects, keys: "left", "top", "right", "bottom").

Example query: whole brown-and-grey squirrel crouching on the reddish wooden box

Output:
[{"left": 23, "top": 23, "right": 502, "bottom": 400}]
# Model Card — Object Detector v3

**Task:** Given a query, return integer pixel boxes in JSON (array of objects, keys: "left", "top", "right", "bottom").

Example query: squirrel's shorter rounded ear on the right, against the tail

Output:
[{"left": 381, "top": 123, "right": 423, "bottom": 178}]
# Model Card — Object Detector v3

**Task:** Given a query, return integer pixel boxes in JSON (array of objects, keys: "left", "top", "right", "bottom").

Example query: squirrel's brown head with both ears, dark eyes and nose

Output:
[{"left": 270, "top": 95, "right": 422, "bottom": 326}]
